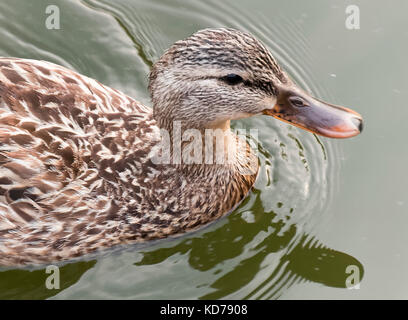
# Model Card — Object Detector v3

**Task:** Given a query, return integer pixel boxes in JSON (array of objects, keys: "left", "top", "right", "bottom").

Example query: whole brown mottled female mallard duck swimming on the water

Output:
[{"left": 0, "top": 29, "right": 362, "bottom": 265}]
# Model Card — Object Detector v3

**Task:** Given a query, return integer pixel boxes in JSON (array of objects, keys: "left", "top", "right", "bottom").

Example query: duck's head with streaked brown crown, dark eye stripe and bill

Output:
[{"left": 149, "top": 28, "right": 362, "bottom": 138}]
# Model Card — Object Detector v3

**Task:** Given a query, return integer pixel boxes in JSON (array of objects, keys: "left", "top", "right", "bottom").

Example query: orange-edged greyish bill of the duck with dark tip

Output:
[{"left": 264, "top": 85, "right": 363, "bottom": 138}]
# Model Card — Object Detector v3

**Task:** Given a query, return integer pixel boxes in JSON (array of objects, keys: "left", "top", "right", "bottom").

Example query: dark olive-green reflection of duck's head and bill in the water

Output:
[{"left": 135, "top": 190, "right": 364, "bottom": 299}]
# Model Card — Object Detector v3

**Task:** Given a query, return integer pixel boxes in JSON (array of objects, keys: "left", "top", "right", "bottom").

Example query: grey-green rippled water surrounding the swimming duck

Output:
[{"left": 0, "top": 0, "right": 408, "bottom": 299}]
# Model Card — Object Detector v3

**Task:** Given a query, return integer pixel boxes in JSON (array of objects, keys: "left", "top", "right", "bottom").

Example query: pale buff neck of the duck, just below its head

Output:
[{"left": 153, "top": 120, "right": 258, "bottom": 175}]
